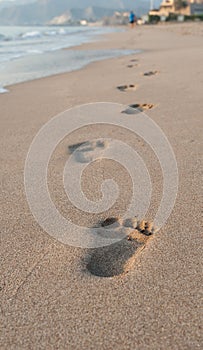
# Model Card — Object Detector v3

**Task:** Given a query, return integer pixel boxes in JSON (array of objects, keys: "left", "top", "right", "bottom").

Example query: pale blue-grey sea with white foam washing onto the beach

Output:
[{"left": 0, "top": 26, "right": 138, "bottom": 93}]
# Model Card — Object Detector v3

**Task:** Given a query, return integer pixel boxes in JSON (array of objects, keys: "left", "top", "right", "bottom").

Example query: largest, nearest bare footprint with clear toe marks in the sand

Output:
[{"left": 87, "top": 217, "right": 157, "bottom": 277}]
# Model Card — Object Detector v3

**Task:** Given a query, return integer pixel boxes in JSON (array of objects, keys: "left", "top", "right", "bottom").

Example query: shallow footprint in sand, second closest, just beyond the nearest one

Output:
[{"left": 68, "top": 139, "right": 109, "bottom": 163}]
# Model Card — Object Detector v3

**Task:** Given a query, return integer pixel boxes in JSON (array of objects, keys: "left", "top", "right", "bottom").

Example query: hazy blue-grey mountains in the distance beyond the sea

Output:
[{"left": 0, "top": 0, "right": 148, "bottom": 25}]
